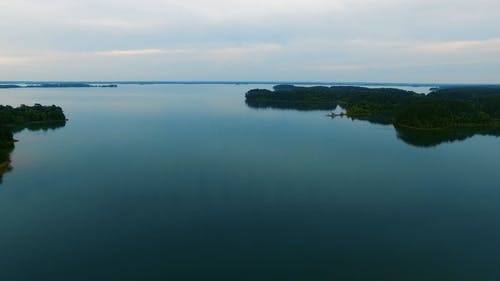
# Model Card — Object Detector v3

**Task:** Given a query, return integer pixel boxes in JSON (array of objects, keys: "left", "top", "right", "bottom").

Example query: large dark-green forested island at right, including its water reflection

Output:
[{"left": 245, "top": 85, "right": 500, "bottom": 146}]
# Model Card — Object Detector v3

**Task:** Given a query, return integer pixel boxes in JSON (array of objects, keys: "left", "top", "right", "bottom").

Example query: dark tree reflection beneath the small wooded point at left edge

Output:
[{"left": 0, "top": 121, "right": 66, "bottom": 185}]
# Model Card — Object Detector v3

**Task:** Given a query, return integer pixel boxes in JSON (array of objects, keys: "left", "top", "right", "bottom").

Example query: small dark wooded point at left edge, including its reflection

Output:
[{"left": 0, "top": 104, "right": 66, "bottom": 183}]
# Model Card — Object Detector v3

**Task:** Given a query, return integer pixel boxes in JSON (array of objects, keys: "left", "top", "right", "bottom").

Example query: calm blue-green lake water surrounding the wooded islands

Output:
[{"left": 0, "top": 84, "right": 500, "bottom": 281}]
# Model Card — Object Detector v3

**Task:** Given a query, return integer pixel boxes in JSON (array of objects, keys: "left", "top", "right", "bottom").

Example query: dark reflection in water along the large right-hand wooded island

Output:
[{"left": 245, "top": 101, "right": 500, "bottom": 148}]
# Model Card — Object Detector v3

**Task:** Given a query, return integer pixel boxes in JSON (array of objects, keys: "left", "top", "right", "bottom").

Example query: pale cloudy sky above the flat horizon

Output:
[{"left": 0, "top": 0, "right": 500, "bottom": 83}]
